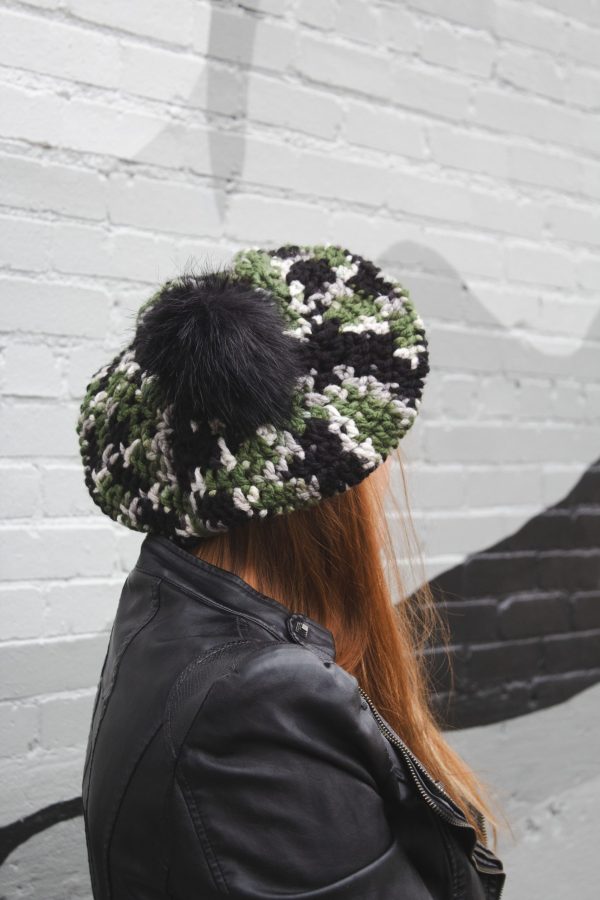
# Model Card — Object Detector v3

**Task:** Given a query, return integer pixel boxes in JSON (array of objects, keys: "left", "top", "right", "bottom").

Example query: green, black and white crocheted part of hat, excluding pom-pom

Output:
[{"left": 77, "top": 244, "right": 429, "bottom": 545}]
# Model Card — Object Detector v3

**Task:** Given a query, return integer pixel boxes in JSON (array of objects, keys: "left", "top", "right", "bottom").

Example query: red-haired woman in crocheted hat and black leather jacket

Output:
[{"left": 78, "top": 245, "right": 505, "bottom": 900}]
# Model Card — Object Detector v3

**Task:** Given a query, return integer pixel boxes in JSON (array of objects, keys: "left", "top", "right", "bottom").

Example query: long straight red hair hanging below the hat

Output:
[{"left": 196, "top": 449, "right": 510, "bottom": 849}]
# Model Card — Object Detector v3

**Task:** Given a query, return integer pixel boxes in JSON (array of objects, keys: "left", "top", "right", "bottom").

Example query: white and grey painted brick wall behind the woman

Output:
[{"left": 0, "top": 0, "right": 600, "bottom": 900}]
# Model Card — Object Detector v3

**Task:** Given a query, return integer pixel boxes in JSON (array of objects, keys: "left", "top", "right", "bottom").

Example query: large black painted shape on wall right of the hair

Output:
[{"left": 430, "top": 459, "right": 600, "bottom": 728}]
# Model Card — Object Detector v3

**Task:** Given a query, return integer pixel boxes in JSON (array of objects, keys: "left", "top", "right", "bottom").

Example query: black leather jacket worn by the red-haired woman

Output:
[{"left": 83, "top": 536, "right": 506, "bottom": 900}]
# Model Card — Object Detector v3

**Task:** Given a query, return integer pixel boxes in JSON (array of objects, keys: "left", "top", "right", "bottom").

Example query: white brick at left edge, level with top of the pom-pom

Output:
[{"left": 0, "top": 277, "right": 112, "bottom": 337}]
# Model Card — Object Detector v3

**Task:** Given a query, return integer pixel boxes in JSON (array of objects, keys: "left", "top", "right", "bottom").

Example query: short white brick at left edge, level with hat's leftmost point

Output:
[{"left": 0, "top": 401, "right": 78, "bottom": 458}]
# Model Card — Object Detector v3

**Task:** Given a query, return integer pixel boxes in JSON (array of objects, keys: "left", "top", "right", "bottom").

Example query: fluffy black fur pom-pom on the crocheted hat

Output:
[{"left": 133, "top": 270, "right": 304, "bottom": 435}]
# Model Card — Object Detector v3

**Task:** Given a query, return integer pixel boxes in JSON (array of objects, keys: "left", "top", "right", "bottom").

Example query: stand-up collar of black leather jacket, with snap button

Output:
[{"left": 137, "top": 534, "right": 335, "bottom": 660}]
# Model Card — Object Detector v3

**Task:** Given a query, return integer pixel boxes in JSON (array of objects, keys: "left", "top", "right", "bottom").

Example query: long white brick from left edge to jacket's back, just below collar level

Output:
[{"left": 0, "top": 634, "right": 108, "bottom": 700}]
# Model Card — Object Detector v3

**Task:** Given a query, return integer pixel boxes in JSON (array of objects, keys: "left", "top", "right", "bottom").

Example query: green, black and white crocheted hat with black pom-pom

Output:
[{"left": 77, "top": 244, "right": 429, "bottom": 544}]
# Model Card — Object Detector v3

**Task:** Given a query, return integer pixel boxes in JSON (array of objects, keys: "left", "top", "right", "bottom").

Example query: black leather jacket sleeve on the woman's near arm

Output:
[{"left": 176, "top": 644, "right": 430, "bottom": 900}]
